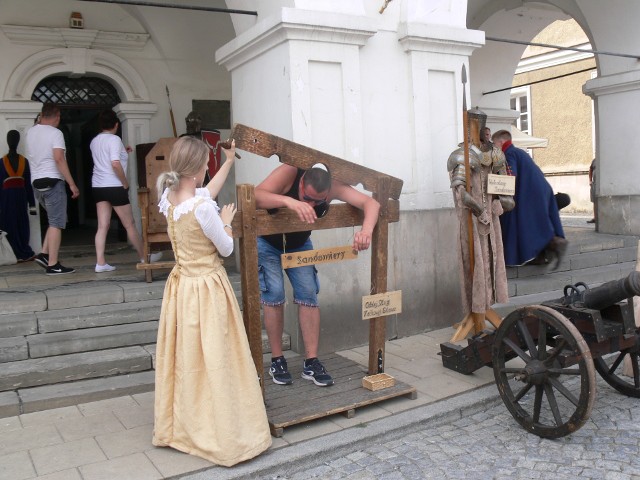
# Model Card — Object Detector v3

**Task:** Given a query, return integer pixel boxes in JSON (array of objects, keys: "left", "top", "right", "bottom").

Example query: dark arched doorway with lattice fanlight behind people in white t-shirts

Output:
[{"left": 31, "top": 75, "right": 120, "bottom": 238}]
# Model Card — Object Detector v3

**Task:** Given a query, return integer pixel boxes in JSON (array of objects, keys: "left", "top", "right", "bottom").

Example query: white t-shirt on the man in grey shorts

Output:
[{"left": 26, "top": 124, "right": 67, "bottom": 182}]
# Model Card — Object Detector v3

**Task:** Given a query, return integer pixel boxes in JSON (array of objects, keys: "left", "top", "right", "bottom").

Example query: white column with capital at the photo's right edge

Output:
[{"left": 582, "top": 70, "right": 640, "bottom": 235}]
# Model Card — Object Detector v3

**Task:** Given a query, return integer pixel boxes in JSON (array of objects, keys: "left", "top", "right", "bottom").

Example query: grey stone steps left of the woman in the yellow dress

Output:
[{"left": 0, "top": 271, "right": 290, "bottom": 417}]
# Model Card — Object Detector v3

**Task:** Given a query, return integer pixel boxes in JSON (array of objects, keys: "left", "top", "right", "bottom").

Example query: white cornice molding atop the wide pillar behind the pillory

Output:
[{"left": 216, "top": 8, "right": 376, "bottom": 71}]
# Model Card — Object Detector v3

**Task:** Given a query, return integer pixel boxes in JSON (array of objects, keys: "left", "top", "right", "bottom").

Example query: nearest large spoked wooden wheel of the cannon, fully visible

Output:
[{"left": 492, "top": 305, "right": 596, "bottom": 438}]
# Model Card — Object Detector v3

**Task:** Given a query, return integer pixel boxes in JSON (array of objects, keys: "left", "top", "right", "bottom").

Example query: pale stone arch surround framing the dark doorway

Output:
[{"left": 0, "top": 48, "right": 158, "bottom": 250}]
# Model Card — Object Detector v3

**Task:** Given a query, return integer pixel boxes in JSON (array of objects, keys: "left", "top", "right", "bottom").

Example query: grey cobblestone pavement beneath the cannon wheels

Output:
[{"left": 253, "top": 379, "right": 640, "bottom": 480}]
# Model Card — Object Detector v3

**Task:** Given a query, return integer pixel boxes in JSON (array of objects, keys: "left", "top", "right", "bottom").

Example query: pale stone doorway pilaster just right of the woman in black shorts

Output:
[{"left": 113, "top": 102, "right": 158, "bottom": 232}]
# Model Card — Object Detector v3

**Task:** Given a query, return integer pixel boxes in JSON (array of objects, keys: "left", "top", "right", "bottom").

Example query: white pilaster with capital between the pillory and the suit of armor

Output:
[{"left": 398, "top": 23, "right": 484, "bottom": 209}]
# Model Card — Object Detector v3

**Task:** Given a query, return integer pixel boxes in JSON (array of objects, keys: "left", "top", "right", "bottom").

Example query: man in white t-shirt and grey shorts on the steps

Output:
[{"left": 26, "top": 103, "right": 80, "bottom": 275}]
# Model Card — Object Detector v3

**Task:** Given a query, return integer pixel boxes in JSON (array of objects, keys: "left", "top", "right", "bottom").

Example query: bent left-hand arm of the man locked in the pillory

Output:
[{"left": 255, "top": 163, "right": 317, "bottom": 223}]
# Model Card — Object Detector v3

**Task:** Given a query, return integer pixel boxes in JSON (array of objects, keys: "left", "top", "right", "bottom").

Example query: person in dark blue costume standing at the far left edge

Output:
[{"left": 0, "top": 130, "right": 36, "bottom": 262}]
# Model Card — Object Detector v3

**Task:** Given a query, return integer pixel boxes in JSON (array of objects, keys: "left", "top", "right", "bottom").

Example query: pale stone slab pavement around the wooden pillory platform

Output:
[{"left": 0, "top": 328, "right": 496, "bottom": 480}]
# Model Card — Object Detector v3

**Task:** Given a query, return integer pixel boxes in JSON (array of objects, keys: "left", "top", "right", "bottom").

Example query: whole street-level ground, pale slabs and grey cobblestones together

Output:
[{"left": 0, "top": 216, "right": 624, "bottom": 480}]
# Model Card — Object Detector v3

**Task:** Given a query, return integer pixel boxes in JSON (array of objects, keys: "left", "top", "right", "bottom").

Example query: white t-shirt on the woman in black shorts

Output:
[{"left": 90, "top": 132, "right": 129, "bottom": 188}]
